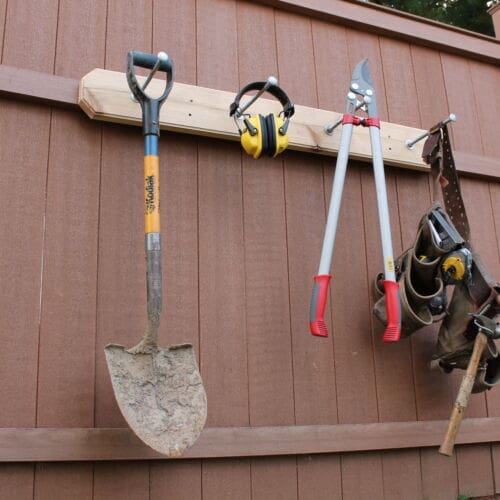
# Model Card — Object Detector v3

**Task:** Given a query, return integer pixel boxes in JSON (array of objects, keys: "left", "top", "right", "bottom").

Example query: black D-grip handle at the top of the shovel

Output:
[{"left": 127, "top": 51, "right": 174, "bottom": 136}]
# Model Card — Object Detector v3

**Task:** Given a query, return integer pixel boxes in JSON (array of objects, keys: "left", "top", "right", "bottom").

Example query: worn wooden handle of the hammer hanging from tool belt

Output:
[{"left": 439, "top": 331, "right": 488, "bottom": 457}]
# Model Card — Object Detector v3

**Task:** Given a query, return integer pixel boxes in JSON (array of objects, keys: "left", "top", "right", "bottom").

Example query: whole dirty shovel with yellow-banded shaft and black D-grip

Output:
[{"left": 104, "top": 52, "right": 207, "bottom": 457}]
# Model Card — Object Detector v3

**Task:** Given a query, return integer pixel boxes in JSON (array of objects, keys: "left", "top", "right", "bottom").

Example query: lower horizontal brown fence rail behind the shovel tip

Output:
[{"left": 0, "top": 417, "right": 500, "bottom": 462}]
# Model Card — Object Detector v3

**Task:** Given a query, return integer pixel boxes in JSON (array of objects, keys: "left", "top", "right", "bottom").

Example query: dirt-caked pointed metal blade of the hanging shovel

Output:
[{"left": 104, "top": 344, "right": 207, "bottom": 457}]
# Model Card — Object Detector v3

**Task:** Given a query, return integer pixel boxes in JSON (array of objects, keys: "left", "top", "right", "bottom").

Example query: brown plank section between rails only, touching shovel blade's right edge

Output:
[{"left": 198, "top": 141, "right": 249, "bottom": 426}]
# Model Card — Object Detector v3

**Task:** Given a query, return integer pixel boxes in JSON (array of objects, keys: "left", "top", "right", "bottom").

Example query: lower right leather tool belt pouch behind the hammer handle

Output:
[{"left": 433, "top": 284, "right": 500, "bottom": 393}]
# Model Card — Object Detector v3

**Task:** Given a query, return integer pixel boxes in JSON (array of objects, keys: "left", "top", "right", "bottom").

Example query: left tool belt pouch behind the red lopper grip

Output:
[{"left": 373, "top": 204, "right": 451, "bottom": 337}]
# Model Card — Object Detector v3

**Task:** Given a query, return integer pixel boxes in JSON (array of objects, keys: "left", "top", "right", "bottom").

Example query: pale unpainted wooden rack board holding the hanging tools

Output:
[{"left": 78, "top": 69, "right": 433, "bottom": 170}]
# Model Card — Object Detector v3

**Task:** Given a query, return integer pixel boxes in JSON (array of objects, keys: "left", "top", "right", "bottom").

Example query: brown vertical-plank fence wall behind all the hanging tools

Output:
[{"left": 0, "top": 0, "right": 500, "bottom": 500}]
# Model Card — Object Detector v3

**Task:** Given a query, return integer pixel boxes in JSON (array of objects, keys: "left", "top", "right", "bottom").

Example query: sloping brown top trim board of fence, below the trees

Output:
[{"left": 256, "top": 0, "right": 500, "bottom": 64}]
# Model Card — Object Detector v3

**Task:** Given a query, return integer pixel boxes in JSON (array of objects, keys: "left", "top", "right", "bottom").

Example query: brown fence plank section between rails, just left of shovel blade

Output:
[{"left": 37, "top": 111, "right": 100, "bottom": 427}]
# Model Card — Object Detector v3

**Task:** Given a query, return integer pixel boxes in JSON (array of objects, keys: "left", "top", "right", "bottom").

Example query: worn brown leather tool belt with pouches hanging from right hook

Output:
[{"left": 373, "top": 123, "right": 500, "bottom": 392}]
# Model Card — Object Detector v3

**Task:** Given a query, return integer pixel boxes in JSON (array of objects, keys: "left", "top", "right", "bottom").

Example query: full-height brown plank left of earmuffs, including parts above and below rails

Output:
[{"left": 196, "top": 0, "right": 251, "bottom": 499}]
